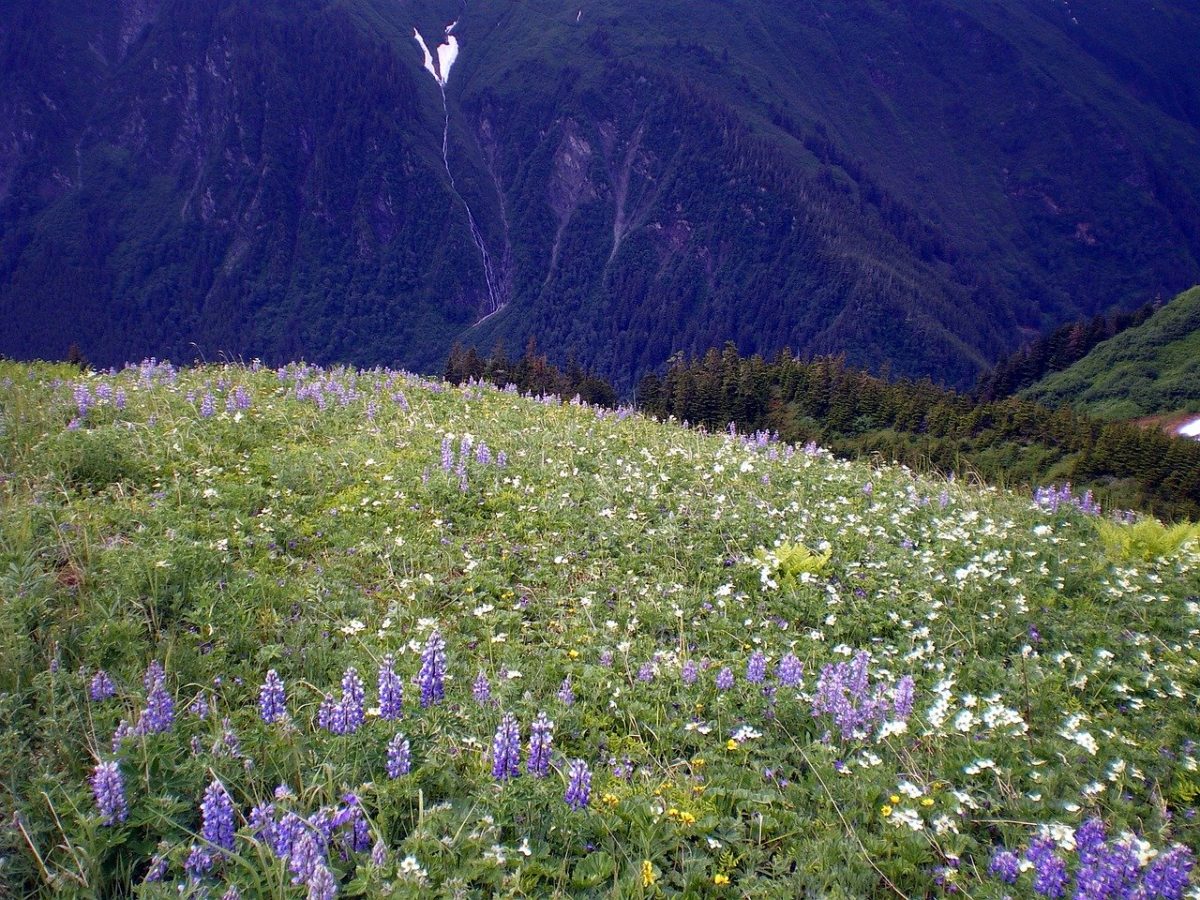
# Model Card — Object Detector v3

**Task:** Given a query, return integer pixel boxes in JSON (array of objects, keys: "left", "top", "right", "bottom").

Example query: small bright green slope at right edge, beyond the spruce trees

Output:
[{"left": 1021, "top": 288, "right": 1200, "bottom": 419}]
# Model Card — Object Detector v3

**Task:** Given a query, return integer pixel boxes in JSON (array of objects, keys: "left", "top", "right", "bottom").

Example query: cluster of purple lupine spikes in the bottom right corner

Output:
[{"left": 988, "top": 818, "right": 1195, "bottom": 900}]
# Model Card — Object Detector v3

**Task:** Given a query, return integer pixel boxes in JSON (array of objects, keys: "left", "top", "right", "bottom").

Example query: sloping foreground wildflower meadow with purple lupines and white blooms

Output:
[{"left": 0, "top": 364, "right": 1200, "bottom": 899}]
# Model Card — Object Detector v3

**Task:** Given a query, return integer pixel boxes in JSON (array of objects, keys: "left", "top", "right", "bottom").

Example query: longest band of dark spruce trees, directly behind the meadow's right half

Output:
[{"left": 637, "top": 344, "right": 1200, "bottom": 520}]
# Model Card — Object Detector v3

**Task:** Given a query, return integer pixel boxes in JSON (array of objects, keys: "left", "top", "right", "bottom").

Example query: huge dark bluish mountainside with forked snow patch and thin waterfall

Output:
[{"left": 0, "top": 0, "right": 1200, "bottom": 389}]
